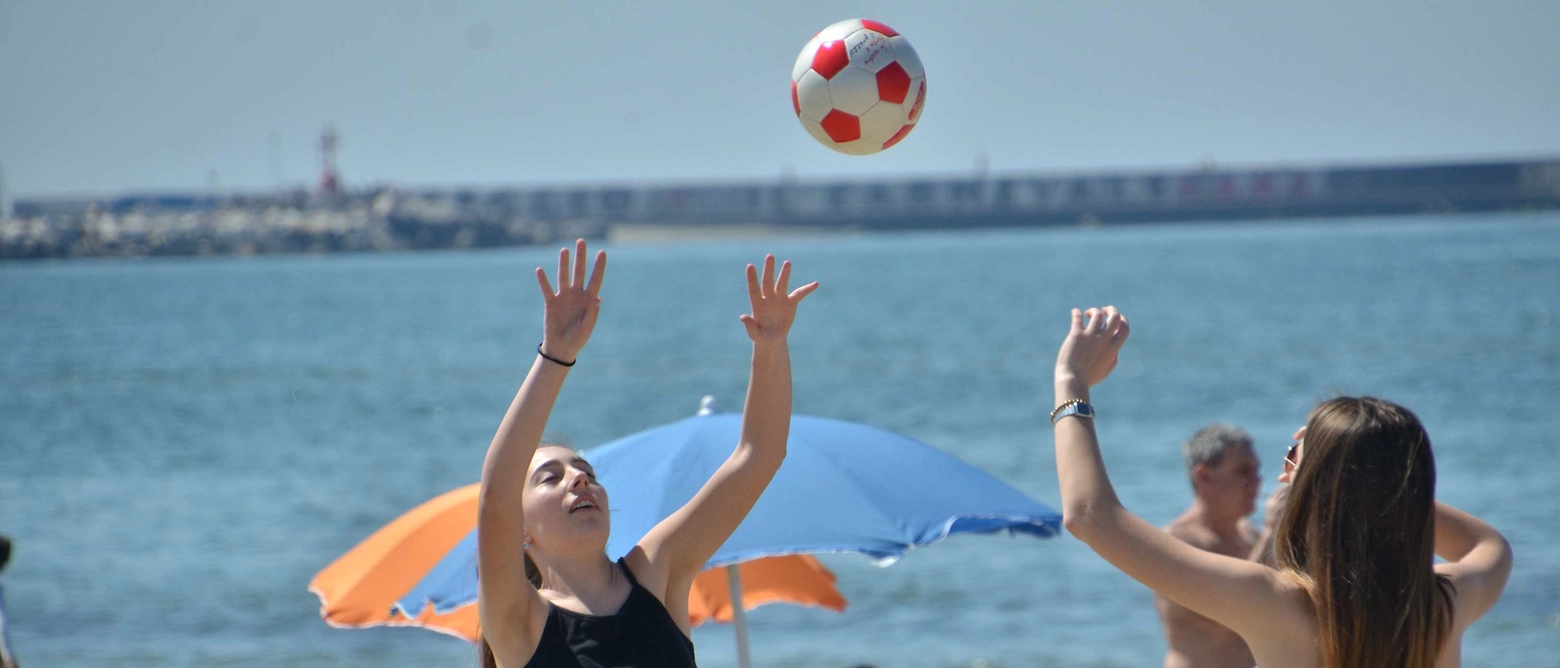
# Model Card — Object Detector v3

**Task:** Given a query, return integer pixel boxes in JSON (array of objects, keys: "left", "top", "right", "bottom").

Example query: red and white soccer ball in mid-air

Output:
[{"left": 791, "top": 19, "right": 927, "bottom": 156}]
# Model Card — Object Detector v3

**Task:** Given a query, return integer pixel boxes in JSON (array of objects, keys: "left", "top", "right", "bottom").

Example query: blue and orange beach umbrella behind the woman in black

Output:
[{"left": 312, "top": 396, "right": 1061, "bottom": 668}]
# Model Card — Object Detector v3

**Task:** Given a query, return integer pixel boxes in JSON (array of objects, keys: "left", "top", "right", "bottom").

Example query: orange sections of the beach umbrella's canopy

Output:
[{"left": 309, "top": 485, "right": 846, "bottom": 641}]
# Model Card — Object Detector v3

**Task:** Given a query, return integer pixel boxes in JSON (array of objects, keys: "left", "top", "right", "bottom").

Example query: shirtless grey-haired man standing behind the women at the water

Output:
[{"left": 1154, "top": 425, "right": 1282, "bottom": 668}]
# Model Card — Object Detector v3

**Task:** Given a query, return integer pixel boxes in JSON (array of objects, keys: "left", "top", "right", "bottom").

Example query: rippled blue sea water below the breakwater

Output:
[{"left": 0, "top": 214, "right": 1560, "bottom": 666}]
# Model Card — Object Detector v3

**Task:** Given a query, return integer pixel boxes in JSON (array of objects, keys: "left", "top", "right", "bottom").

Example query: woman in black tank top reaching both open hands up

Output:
[{"left": 477, "top": 240, "right": 817, "bottom": 668}]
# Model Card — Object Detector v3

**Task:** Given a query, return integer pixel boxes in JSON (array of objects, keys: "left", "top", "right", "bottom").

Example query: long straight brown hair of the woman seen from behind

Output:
[{"left": 1275, "top": 396, "right": 1454, "bottom": 668}]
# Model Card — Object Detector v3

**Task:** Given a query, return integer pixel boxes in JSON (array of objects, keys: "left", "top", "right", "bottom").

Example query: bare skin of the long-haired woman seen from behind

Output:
[{"left": 1053, "top": 306, "right": 1512, "bottom": 668}]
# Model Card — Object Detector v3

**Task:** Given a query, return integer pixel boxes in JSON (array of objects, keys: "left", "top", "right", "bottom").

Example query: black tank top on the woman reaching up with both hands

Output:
[{"left": 526, "top": 559, "right": 697, "bottom": 668}]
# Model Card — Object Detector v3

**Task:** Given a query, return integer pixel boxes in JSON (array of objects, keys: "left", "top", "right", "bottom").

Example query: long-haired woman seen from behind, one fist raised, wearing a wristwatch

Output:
[{"left": 1051, "top": 306, "right": 1512, "bottom": 668}]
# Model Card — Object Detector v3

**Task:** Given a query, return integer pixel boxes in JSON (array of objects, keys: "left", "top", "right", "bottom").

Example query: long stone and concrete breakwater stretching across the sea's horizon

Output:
[{"left": 0, "top": 159, "right": 1560, "bottom": 259}]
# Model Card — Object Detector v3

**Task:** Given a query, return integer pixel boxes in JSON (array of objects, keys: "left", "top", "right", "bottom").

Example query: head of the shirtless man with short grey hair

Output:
[{"left": 1181, "top": 423, "right": 1262, "bottom": 517}]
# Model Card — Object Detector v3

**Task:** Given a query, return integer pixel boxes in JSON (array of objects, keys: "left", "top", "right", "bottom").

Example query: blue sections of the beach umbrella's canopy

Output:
[{"left": 398, "top": 400, "right": 1061, "bottom": 616}]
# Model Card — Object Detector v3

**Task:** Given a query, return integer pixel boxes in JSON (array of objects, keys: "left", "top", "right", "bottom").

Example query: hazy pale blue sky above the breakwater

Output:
[{"left": 0, "top": 0, "right": 1560, "bottom": 197}]
